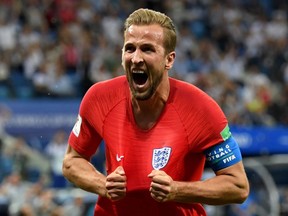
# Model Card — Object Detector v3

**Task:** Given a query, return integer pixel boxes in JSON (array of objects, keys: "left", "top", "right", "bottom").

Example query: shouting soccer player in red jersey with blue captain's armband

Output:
[{"left": 63, "top": 9, "right": 249, "bottom": 216}]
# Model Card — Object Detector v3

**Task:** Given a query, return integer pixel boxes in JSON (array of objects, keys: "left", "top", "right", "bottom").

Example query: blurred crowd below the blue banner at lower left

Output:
[{"left": 0, "top": 115, "right": 104, "bottom": 216}]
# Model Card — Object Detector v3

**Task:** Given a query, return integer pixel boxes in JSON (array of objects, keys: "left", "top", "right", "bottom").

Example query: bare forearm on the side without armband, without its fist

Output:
[{"left": 63, "top": 157, "right": 107, "bottom": 196}]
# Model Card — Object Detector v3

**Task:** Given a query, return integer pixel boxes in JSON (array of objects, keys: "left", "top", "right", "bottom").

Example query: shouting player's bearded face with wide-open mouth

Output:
[{"left": 122, "top": 25, "right": 167, "bottom": 100}]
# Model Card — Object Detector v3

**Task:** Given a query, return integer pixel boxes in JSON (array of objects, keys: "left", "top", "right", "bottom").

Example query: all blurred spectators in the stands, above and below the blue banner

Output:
[{"left": 0, "top": 0, "right": 288, "bottom": 216}]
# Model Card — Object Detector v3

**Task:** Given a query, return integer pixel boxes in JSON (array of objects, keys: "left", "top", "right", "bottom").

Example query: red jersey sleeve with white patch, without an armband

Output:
[{"left": 69, "top": 76, "right": 128, "bottom": 158}]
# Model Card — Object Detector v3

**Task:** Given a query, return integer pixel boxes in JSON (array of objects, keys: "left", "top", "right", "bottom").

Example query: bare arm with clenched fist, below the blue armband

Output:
[{"left": 148, "top": 161, "right": 249, "bottom": 205}]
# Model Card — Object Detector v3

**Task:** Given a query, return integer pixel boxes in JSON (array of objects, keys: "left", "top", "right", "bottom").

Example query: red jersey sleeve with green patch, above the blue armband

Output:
[{"left": 177, "top": 80, "right": 231, "bottom": 153}]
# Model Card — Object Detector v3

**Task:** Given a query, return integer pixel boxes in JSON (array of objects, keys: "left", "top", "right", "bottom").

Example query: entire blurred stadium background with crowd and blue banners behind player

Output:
[{"left": 0, "top": 0, "right": 288, "bottom": 216}]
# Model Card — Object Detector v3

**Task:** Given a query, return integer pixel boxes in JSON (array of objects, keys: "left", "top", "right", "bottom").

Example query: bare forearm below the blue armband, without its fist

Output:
[{"left": 171, "top": 162, "right": 249, "bottom": 205}]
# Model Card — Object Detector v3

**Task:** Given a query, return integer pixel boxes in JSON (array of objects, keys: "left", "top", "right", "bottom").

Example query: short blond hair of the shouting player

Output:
[{"left": 124, "top": 8, "right": 177, "bottom": 53}]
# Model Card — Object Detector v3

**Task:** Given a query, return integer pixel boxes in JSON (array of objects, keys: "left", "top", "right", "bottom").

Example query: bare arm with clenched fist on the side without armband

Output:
[{"left": 62, "top": 145, "right": 126, "bottom": 200}]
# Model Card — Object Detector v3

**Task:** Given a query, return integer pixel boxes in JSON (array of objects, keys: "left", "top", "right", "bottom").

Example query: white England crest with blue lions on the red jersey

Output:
[{"left": 152, "top": 147, "right": 171, "bottom": 170}]
